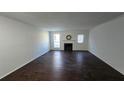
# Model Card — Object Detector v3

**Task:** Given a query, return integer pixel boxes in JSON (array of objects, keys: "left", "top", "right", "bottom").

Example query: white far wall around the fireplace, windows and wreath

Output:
[{"left": 50, "top": 31, "right": 89, "bottom": 50}]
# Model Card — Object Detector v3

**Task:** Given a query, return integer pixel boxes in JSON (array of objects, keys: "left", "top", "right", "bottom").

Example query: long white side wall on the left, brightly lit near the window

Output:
[{"left": 0, "top": 16, "right": 49, "bottom": 78}]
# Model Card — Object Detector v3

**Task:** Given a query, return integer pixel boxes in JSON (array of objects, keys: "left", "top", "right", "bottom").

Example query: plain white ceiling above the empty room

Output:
[{"left": 0, "top": 12, "right": 123, "bottom": 31}]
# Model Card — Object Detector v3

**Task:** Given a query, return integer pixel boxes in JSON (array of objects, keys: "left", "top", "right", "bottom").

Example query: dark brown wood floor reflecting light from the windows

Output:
[{"left": 1, "top": 51, "right": 124, "bottom": 81}]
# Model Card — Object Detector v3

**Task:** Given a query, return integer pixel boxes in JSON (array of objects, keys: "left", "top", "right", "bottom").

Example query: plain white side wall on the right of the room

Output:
[{"left": 89, "top": 17, "right": 124, "bottom": 74}]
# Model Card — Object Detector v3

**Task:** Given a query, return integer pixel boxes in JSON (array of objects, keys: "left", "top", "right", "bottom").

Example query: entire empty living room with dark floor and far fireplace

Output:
[{"left": 0, "top": 12, "right": 124, "bottom": 81}]
